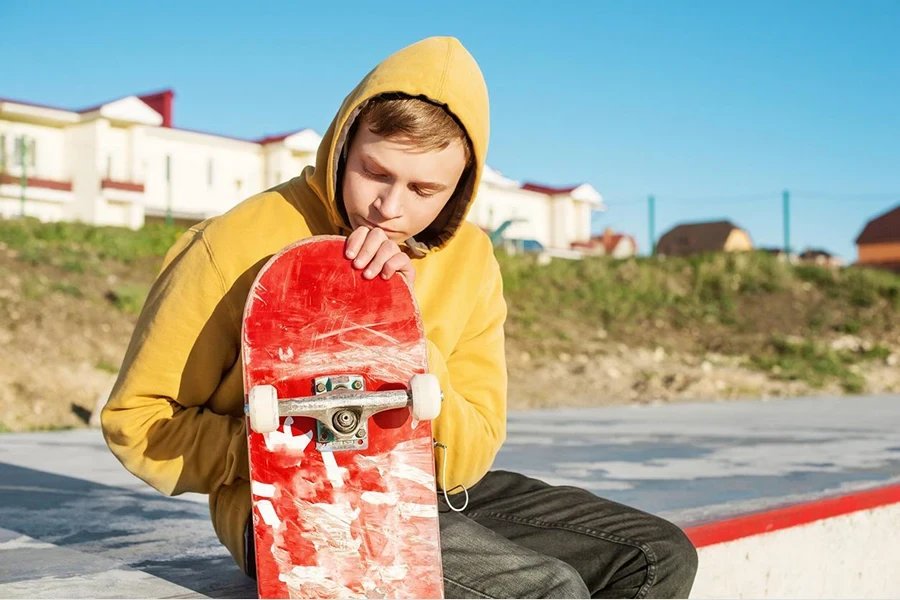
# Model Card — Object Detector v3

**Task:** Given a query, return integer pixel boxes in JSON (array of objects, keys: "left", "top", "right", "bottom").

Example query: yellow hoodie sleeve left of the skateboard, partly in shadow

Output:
[{"left": 101, "top": 231, "right": 249, "bottom": 495}]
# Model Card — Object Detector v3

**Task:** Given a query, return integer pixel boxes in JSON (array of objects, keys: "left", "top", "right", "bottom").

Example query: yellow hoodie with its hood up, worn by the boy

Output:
[{"left": 102, "top": 38, "right": 507, "bottom": 568}]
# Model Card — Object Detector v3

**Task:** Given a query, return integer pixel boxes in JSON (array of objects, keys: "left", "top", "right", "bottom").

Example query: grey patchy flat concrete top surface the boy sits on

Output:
[{"left": 0, "top": 396, "right": 900, "bottom": 598}]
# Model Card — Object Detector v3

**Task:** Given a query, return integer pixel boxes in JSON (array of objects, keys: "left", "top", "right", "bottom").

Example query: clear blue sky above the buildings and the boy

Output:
[{"left": 0, "top": 0, "right": 900, "bottom": 261}]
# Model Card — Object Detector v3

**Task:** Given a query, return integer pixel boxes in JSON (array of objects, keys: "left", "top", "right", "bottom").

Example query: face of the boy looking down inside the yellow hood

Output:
[{"left": 342, "top": 122, "right": 465, "bottom": 243}]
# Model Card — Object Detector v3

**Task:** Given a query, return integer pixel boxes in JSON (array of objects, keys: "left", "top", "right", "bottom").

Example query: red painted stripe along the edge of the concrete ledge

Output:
[{"left": 685, "top": 484, "right": 900, "bottom": 548}]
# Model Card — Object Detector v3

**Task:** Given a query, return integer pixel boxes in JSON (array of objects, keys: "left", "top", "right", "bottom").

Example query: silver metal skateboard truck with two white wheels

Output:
[{"left": 246, "top": 374, "right": 443, "bottom": 451}]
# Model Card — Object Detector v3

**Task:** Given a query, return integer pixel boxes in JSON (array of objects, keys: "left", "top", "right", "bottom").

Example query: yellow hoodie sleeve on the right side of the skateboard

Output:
[{"left": 428, "top": 252, "right": 507, "bottom": 492}]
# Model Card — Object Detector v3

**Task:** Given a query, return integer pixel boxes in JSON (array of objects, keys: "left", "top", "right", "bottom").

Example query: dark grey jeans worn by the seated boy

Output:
[{"left": 248, "top": 471, "right": 697, "bottom": 598}]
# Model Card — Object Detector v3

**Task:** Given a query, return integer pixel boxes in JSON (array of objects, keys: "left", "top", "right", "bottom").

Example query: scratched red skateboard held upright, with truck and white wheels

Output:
[{"left": 241, "top": 236, "right": 444, "bottom": 598}]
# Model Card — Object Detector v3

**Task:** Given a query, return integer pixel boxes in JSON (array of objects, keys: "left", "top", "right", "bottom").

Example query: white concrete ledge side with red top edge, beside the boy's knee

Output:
[{"left": 686, "top": 485, "right": 900, "bottom": 598}]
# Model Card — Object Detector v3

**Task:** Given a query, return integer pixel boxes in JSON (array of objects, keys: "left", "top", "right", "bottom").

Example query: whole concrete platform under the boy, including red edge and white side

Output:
[{"left": 0, "top": 396, "right": 900, "bottom": 598}]
